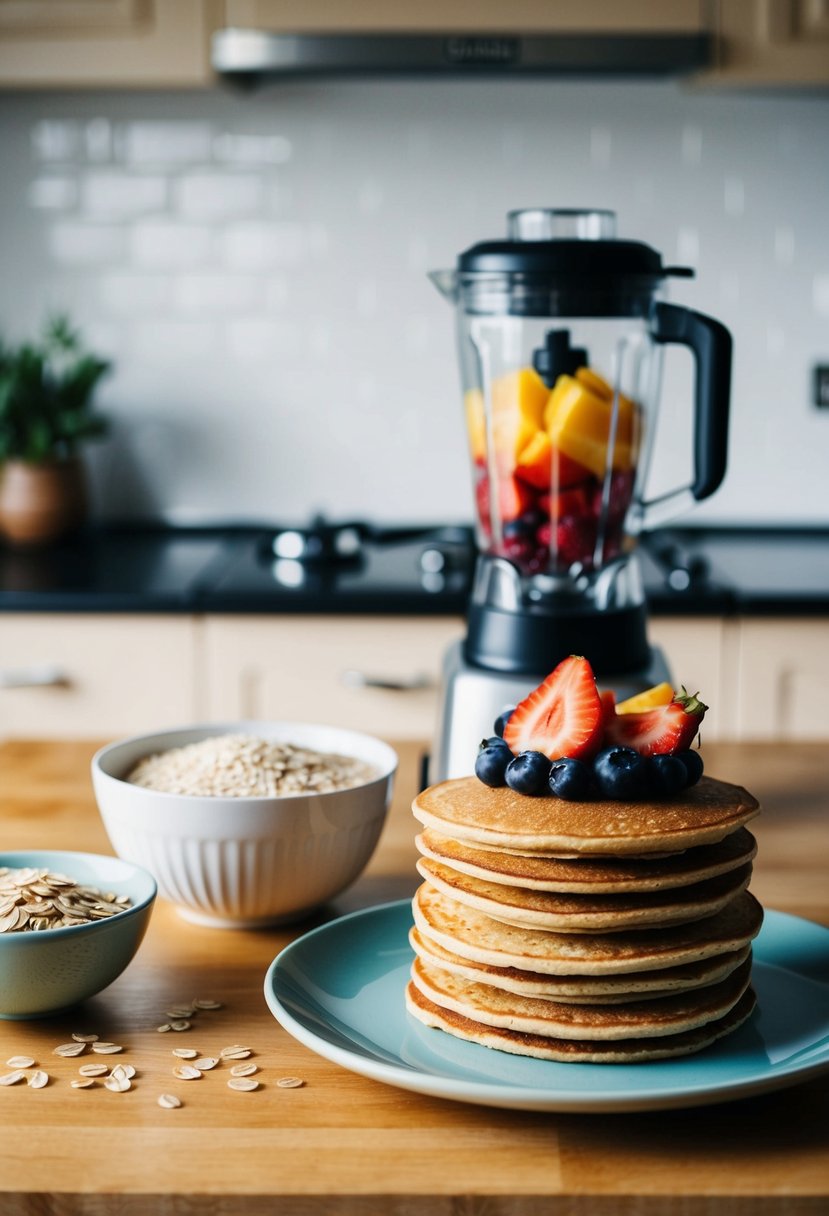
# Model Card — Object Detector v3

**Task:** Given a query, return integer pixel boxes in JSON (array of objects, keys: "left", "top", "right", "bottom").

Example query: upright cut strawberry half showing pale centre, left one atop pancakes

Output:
[{"left": 503, "top": 654, "right": 604, "bottom": 760}]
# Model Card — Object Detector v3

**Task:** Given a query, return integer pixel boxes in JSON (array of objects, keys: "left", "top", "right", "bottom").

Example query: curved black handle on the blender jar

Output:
[{"left": 653, "top": 300, "right": 732, "bottom": 502}]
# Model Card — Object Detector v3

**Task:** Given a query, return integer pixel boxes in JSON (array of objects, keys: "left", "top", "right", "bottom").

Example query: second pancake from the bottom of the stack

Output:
[{"left": 411, "top": 958, "right": 751, "bottom": 1040}]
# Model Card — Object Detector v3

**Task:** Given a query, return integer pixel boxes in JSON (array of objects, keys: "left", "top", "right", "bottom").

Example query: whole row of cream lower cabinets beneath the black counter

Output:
[{"left": 0, "top": 613, "right": 829, "bottom": 742}]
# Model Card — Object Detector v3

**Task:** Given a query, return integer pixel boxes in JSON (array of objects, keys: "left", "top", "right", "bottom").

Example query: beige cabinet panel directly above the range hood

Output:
[{"left": 225, "top": 0, "right": 704, "bottom": 34}]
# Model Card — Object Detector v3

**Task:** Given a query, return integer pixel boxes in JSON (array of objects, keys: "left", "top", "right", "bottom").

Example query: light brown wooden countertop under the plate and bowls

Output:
[{"left": 0, "top": 742, "right": 829, "bottom": 1216}]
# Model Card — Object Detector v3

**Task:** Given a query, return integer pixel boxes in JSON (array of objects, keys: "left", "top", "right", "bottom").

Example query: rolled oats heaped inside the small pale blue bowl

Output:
[{"left": 0, "top": 866, "right": 131, "bottom": 933}]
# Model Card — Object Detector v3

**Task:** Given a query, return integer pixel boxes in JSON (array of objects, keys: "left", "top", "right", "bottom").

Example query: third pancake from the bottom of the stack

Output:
[{"left": 408, "top": 928, "right": 751, "bottom": 1004}]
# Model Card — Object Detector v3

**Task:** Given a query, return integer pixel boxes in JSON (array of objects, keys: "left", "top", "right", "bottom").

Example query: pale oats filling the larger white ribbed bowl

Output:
[{"left": 126, "top": 734, "right": 377, "bottom": 798}]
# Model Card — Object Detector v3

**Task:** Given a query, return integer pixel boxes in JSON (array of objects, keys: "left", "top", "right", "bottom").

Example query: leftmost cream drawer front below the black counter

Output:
[{"left": 0, "top": 613, "right": 198, "bottom": 739}]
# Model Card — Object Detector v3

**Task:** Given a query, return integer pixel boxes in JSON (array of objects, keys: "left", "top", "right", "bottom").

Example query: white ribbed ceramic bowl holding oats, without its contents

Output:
[{"left": 92, "top": 721, "right": 397, "bottom": 928}]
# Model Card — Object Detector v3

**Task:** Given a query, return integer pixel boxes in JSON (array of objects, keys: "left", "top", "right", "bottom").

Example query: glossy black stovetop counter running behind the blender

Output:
[{"left": 0, "top": 525, "right": 829, "bottom": 615}]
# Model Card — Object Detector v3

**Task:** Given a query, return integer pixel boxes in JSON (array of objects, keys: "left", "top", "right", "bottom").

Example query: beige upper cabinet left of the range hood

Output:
[{"left": 0, "top": 0, "right": 222, "bottom": 89}]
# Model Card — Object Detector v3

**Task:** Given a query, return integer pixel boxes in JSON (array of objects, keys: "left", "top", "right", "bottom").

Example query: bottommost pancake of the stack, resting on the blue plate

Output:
[{"left": 406, "top": 981, "right": 755, "bottom": 1064}]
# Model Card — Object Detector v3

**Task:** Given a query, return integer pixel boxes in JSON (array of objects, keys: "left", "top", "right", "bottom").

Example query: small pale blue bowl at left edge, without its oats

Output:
[{"left": 0, "top": 849, "right": 156, "bottom": 1019}]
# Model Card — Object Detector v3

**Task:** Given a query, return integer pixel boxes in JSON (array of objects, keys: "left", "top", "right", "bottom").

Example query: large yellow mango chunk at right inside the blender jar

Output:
[{"left": 545, "top": 376, "right": 637, "bottom": 479}]
